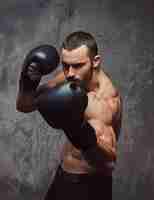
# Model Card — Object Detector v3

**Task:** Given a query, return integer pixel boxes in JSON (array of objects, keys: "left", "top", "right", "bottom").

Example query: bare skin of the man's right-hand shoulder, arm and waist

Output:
[{"left": 62, "top": 72, "right": 120, "bottom": 174}]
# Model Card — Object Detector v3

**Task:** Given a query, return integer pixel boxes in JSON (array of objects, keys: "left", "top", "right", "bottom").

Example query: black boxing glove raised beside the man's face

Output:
[{"left": 19, "top": 45, "right": 60, "bottom": 92}]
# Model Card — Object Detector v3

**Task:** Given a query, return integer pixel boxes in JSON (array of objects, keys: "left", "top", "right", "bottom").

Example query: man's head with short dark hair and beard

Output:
[{"left": 61, "top": 31, "right": 100, "bottom": 84}]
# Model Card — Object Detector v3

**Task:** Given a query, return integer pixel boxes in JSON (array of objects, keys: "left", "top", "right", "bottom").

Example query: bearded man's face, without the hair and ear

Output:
[{"left": 61, "top": 45, "right": 93, "bottom": 84}]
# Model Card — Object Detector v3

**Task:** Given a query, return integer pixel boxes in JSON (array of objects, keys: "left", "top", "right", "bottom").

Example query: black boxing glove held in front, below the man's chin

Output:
[{"left": 35, "top": 81, "right": 96, "bottom": 151}]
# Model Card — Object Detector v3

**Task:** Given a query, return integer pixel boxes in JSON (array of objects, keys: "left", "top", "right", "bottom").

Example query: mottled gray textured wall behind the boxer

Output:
[{"left": 0, "top": 0, "right": 154, "bottom": 200}]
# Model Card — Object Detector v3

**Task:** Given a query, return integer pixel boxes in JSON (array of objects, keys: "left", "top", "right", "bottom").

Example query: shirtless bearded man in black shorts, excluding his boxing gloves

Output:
[{"left": 16, "top": 31, "right": 122, "bottom": 200}]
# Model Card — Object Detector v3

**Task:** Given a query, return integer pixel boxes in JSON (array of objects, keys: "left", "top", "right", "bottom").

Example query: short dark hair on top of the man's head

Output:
[{"left": 62, "top": 31, "right": 98, "bottom": 56}]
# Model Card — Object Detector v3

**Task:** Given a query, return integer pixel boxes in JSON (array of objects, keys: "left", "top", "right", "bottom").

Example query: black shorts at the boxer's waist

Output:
[{"left": 45, "top": 167, "right": 112, "bottom": 200}]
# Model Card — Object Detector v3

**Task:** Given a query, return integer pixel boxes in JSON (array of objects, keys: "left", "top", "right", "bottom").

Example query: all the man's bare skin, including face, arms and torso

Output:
[{"left": 16, "top": 45, "right": 121, "bottom": 174}]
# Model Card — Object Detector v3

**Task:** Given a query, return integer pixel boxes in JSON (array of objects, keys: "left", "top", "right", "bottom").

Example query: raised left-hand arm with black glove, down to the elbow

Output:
[{"left": 16, "top": 45, "right": 59, "bottom": 113}]
